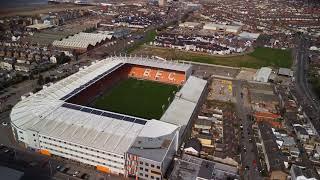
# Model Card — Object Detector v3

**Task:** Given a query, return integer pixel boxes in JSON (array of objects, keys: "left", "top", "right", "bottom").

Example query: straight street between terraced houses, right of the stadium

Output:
[{"left": 233, "top": 81, "right": 263, "bottom": 180}]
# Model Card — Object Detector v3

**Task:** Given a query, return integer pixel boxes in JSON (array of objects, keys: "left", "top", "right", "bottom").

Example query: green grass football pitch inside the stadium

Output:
[{"left": 92, "top": 78, "right": 179, "bottom": 119}]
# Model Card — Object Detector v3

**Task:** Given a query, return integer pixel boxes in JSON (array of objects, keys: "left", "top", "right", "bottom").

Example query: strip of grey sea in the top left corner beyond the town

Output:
[{"left": 0, "top": 0, "right": 48, "bottom": 9}]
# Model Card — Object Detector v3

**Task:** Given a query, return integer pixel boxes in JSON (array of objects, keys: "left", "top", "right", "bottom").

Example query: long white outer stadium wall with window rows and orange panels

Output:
[{"left": 12, "top": 124, "right": 125, "bottom": 174}]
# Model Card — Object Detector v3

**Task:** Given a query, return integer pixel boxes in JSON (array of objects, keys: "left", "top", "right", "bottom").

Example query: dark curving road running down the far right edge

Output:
[{"left": 294, "top": 36, "right": 320, "bottom": 133}]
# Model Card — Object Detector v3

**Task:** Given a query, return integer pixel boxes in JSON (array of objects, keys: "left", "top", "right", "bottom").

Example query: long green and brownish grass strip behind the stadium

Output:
[{"left": 133, "top": 46, "right": 292, "bottom": 69}]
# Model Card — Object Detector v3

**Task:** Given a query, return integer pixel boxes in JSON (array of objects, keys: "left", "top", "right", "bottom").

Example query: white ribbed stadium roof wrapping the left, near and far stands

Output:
[{"left": 10, "top": 57, "right": 194, "bottom": 154}]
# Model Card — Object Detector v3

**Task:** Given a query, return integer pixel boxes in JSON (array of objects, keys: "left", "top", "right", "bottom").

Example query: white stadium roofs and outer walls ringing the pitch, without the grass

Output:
[{"left": 10, "top": 57, "right": 207, "bottom": 179}]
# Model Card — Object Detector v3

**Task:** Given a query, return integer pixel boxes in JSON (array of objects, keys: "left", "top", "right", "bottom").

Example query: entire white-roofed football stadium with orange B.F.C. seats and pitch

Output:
[{"left": 10, "top": 57, "right": 207, "bottom": 179}]
